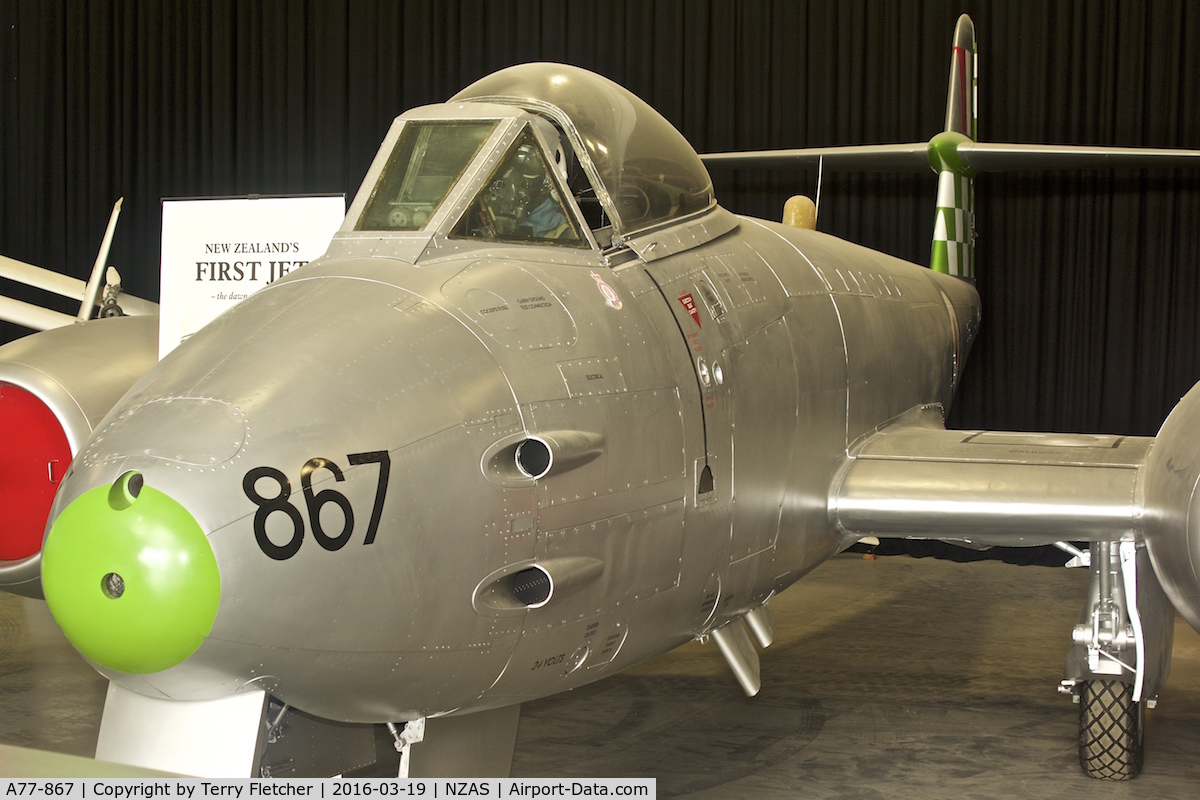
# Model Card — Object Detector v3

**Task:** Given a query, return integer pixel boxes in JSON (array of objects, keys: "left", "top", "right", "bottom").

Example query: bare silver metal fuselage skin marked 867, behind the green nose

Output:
[{"left": 46, "top": 217, "right": 973, "bottom": 722}]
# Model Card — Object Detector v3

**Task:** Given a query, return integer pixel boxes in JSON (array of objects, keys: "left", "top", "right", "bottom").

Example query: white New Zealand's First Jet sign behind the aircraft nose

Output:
[{"left": 158, "top": 194, "right": 346, "bottom": 359}]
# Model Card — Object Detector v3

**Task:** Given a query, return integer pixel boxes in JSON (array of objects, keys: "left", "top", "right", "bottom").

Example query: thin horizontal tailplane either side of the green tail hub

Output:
[{"left": 701, "top": 138, "right": 1200, "bottom": 173}]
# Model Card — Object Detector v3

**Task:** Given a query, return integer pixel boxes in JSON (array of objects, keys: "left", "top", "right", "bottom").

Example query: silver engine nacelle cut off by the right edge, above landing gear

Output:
[{"left": 1145, "top": 384, "right": 1200, "bottom": 631}]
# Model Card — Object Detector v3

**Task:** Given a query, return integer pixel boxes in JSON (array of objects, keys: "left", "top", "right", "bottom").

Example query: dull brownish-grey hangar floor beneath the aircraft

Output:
[{"left": 0, "top": 554, "right": 1200, "bottom": 799}]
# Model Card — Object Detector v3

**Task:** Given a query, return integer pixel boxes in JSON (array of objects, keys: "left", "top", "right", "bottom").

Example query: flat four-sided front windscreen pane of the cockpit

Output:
[{"left": 356, "top": 120, "right": 496, "bottom": 230}]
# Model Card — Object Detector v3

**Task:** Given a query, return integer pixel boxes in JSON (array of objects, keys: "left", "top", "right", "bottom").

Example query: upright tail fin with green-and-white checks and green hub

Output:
[{"left": 929, "top": 14, "right": 979, "bottom": 281}]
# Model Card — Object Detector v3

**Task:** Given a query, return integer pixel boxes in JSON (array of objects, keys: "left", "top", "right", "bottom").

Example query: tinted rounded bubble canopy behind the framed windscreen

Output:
[{"left": 451, "top": 64, "right": 715, "bottom": 235}]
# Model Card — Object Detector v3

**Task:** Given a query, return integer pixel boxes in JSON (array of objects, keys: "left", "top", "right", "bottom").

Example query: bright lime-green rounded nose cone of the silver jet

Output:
[{"left": 42, "top": 471, "right": 221, "bottom": 674}]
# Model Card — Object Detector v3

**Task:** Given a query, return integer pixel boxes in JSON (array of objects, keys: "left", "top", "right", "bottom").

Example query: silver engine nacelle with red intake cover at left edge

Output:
[{"left": 0, "top": 317, "right": 158, "bottom": 597}]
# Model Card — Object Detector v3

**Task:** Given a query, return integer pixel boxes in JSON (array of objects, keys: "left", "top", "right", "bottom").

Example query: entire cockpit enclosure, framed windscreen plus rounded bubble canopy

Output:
[{"left": 343, "top": 64, "right": 715, "bottom": 247}]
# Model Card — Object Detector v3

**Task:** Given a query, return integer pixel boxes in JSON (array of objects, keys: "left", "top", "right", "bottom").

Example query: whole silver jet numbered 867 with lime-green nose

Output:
[{"left": 7, "top": 17, "right": 1200, "bottom": 778}]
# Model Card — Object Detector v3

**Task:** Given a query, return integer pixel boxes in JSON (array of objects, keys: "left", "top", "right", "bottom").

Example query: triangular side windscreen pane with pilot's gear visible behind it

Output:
[{"left": 452, "top": 127, "right": 587, "bottom": 247}]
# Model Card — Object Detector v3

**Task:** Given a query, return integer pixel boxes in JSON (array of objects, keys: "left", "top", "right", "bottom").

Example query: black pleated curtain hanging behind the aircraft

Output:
[{"left": 0, "top": 0, "right": 1200, "bottom": 450}]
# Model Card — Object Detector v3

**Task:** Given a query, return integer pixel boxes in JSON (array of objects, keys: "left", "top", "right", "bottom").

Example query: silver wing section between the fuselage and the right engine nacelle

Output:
[{"left": 829, "top": 407, "right": 1154, "bottom": 546}]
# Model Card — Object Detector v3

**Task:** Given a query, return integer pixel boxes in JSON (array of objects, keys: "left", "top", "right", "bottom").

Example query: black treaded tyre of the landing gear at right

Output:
[{"left": 1079, "top": 680, "right": 1144, "bottom": 781}]
